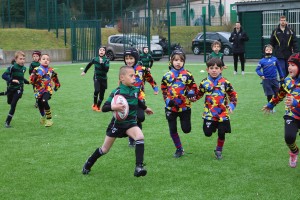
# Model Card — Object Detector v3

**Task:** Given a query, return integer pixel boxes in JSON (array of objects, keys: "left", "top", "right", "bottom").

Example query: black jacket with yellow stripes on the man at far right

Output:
[{"left": 270, "top": 25, "right": 298, "bottom": 59}]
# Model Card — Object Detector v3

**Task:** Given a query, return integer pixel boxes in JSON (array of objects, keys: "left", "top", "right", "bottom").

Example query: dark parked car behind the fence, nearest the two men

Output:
[{"left": 192, "top": 32, "right": 232, "bottom": 56}]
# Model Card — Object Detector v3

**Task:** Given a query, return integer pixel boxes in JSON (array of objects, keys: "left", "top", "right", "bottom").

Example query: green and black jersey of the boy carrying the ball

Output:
[{"left": 102, "top": 83, "right": 147, "bottom": 127}]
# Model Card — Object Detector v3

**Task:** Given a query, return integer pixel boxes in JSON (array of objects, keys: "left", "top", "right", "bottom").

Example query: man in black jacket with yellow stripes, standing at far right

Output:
[{"left": 270, "top": 16, "right": 298, "bottom": 77}]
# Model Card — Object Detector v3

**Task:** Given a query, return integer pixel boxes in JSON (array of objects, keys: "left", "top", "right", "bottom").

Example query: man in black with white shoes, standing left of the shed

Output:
[{"left": 229, "top": 22, "right": 249, "bottom": 75}]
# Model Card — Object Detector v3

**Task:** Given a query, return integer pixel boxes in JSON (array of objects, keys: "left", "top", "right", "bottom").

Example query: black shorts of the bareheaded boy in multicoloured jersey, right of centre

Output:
[{"left": 203, "top": 119, "right": 231, "bottom": 135}]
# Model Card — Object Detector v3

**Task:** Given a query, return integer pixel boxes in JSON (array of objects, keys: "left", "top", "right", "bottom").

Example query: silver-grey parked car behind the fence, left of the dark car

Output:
[{"left": 106, "top": 34, "right": 163, "bottom": 61}]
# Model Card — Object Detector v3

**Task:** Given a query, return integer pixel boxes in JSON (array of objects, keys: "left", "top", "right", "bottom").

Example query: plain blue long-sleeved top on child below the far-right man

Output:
[{"left": 256, "top": 56, "right": 284, "bottom": 79}]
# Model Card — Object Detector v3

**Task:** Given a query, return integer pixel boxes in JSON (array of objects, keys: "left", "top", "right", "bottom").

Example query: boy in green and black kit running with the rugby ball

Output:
[{"left": 82, "top": 66, "right": 153, "bottom": 177}]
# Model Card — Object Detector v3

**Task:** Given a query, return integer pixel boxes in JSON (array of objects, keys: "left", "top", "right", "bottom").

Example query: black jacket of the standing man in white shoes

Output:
[{"left": 229, "top": 27, "right": 249, "bottom": 53}]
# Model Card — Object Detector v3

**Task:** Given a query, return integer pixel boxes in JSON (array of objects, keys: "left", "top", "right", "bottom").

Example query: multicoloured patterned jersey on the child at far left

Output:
[{"left": 30, "top": 65, "right": 60, "bottom": 98}]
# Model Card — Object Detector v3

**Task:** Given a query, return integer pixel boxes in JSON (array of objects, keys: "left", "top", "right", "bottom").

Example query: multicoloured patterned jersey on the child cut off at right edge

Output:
[{"left": 267, "top": 76, "right": 300, "bottom": 120}]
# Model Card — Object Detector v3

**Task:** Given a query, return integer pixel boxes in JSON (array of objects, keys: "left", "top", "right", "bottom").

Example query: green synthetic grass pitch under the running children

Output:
[{"left": 0, "top": 62, "right": 300, "bottom": 200}]
